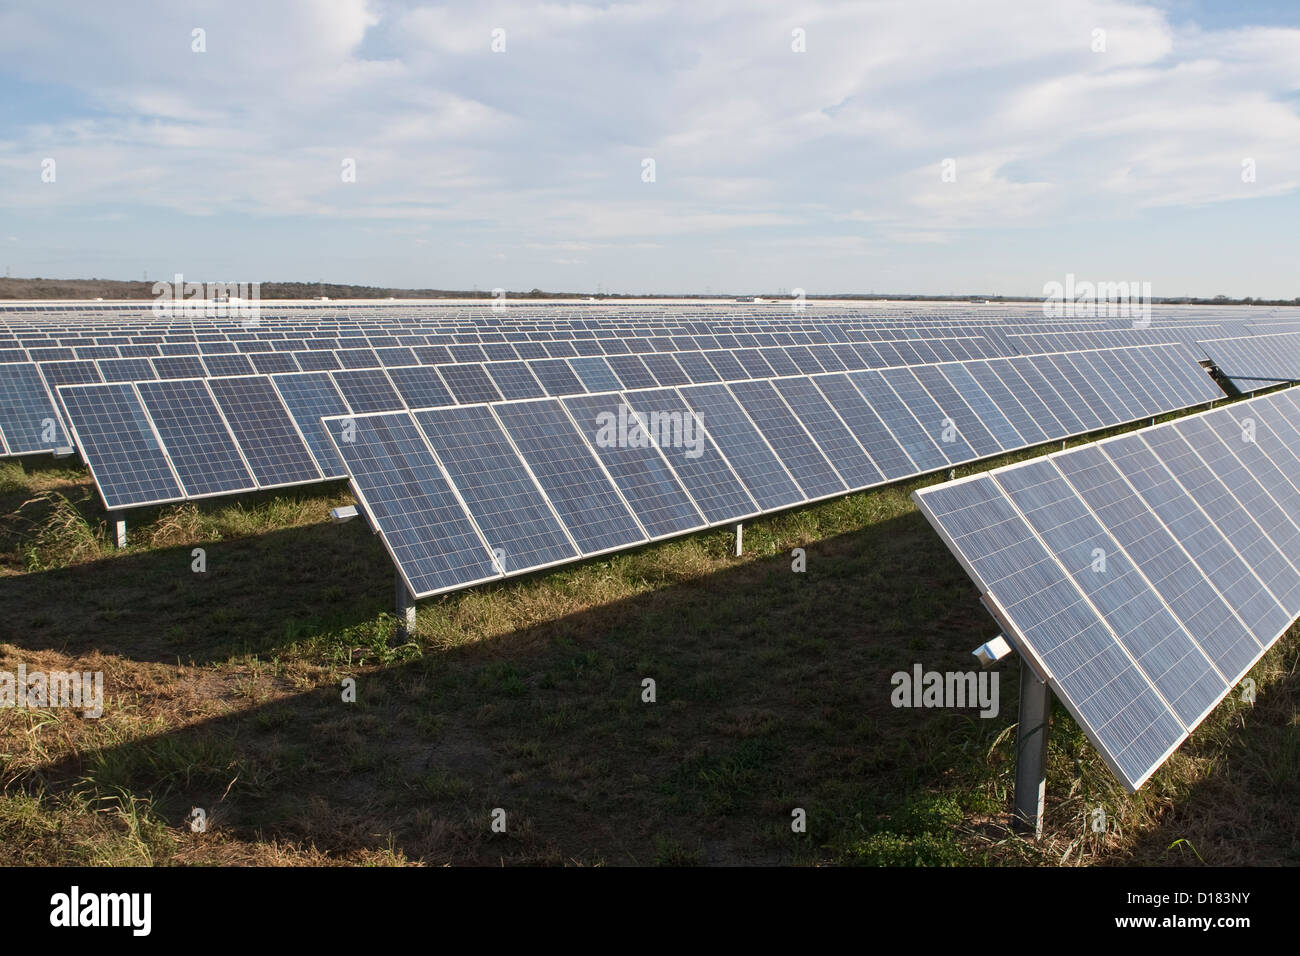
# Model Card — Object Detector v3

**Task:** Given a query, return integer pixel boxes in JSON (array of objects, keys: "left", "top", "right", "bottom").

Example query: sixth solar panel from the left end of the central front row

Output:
[{"left": 680, "top": 385, "right": 806, "bottom": 511}]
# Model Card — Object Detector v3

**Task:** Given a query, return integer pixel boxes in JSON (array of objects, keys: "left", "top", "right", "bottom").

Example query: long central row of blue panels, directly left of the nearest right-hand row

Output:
[{"left": 324, "top": 347, "right": 1222, "bottom": 597}]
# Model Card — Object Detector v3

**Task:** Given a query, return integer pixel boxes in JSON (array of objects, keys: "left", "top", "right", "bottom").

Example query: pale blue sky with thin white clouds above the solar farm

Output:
[{"left": 0, "top": 0, "right": 1300, "bottom": 299}]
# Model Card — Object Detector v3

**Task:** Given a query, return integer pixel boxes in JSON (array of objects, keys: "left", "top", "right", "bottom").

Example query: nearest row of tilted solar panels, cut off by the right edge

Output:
[{"left": 913, "top": 390, "right": 1300, "bottom": 791}]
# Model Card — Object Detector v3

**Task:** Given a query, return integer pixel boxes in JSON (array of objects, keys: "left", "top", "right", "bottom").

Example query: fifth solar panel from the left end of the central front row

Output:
[{"left": 624, "top": 387, "right": 759, "bottom": 524}]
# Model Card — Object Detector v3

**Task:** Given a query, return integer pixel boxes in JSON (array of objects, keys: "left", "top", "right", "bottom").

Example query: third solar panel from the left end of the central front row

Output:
[{"left": 495, "top": 401, "right": 646, "bottom": 554}]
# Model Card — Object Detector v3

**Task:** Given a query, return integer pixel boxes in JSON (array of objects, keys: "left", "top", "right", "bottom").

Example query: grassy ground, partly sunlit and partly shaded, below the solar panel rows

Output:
[{"left": 0, "top": 403, "right": 1300, "bottom": 866}]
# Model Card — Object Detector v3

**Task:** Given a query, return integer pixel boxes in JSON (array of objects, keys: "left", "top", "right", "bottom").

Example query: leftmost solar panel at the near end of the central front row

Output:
[{"left": 326, "top": 414, "right": 501, "bottom": 597}]
